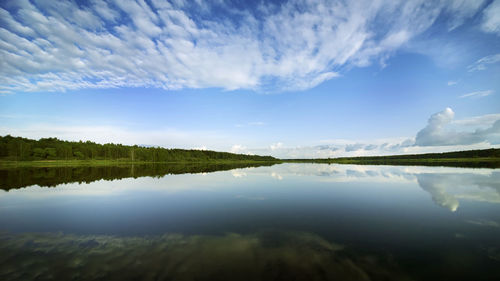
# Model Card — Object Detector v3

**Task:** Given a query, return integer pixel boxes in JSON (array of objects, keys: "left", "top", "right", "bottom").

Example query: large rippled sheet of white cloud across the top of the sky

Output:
[{"left": 0, "top": 0, "right": 492, "bottom": 93}]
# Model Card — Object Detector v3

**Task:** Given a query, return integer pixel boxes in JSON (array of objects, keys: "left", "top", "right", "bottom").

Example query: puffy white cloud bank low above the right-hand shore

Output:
[{"left": 237, "top": 108, "right": 500, "bottom": 159}]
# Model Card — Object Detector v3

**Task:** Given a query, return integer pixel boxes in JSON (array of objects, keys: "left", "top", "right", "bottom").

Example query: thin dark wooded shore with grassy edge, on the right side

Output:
[{"left": 284, "top": 148, "right": 500, "bottom": 168}]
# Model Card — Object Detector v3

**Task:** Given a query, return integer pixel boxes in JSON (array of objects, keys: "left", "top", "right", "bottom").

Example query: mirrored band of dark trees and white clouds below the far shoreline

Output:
[{"left": 0, "top": 163, "right": 500, "bottom": 212}]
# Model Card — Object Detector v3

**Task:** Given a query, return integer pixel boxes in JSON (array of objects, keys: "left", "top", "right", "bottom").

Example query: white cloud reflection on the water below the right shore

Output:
[{"left": 234, "top": 164, "right": 500, "bottom": 212}]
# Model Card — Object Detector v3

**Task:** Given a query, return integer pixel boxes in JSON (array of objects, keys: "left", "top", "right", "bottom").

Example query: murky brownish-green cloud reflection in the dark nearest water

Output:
[{"left": 0, "top": 231, "right": 409, "bottom": 280}]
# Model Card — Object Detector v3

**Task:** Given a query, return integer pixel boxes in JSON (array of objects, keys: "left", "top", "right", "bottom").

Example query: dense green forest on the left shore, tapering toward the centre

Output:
[{"left": 0, "top": 135, "right": 278, "bottom": 162}]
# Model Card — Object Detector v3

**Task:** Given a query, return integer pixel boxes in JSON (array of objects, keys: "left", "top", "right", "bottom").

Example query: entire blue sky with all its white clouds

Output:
[{"left": 0, "top": 0, "right": 500, "bottom": 158}]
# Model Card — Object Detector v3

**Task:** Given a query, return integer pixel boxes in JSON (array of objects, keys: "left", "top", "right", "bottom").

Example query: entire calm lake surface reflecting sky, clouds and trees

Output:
[{"left": 0, "top": 164, "right": 500, "bottom": 280}]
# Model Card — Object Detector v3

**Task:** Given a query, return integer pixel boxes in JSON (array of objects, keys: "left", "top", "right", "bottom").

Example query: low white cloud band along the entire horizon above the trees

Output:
[{"left": 0, "top": 108, "right": 500, "bottom": 159}]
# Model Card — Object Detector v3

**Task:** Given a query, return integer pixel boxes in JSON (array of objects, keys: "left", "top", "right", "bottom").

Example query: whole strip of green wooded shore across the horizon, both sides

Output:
[{"left": 0, "top": 135, "right": 500, "bottom": 168}]
